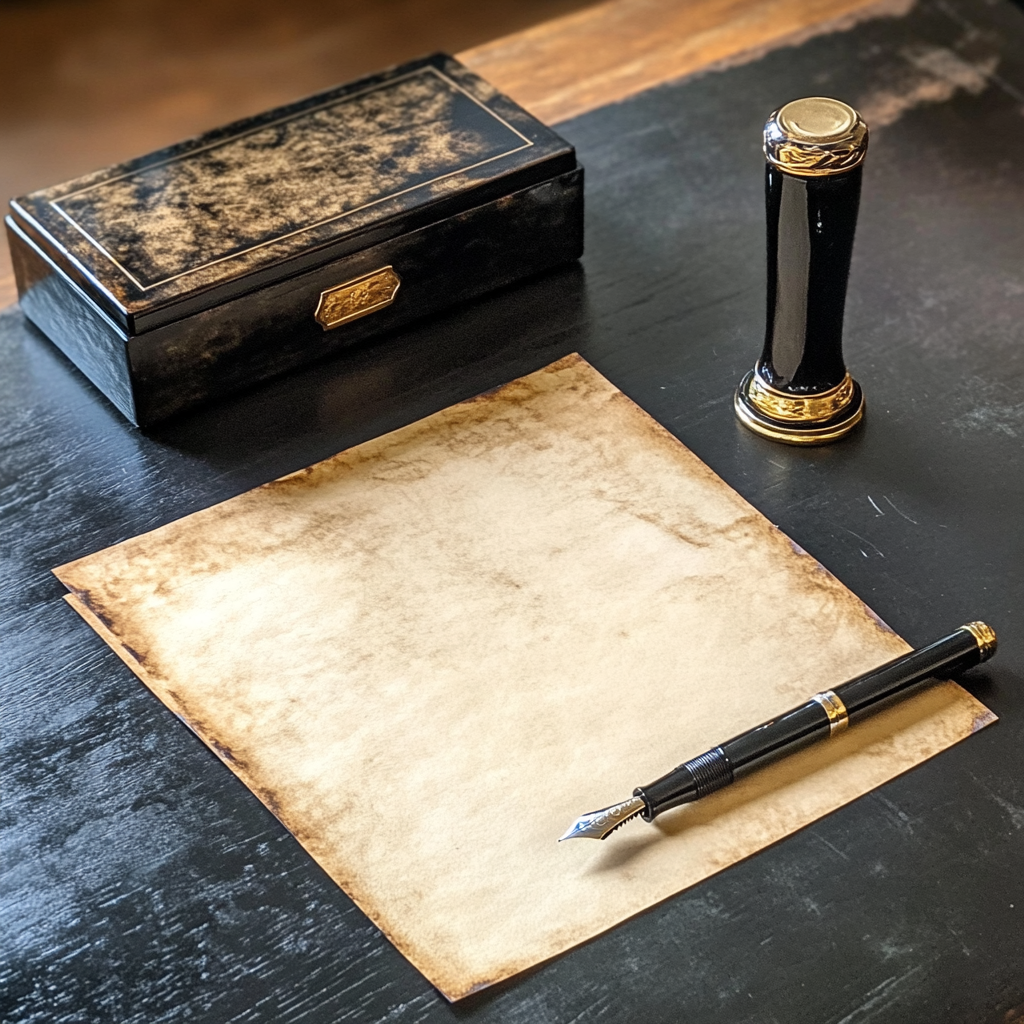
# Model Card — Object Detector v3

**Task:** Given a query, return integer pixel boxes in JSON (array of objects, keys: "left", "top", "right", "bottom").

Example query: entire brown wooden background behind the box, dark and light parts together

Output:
[{"left": 0, "top": 0, "right": 897, "bottom": 307}]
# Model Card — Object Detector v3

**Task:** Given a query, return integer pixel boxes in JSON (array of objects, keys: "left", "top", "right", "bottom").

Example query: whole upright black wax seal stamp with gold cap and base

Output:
[{"left": 735, "top": 96, "right": 867, "bottom": 444}]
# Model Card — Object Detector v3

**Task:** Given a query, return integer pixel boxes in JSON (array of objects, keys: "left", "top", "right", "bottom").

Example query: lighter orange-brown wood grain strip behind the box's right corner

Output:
[{"left": 459, "top": 0, "right": 912, "bottom": 124}]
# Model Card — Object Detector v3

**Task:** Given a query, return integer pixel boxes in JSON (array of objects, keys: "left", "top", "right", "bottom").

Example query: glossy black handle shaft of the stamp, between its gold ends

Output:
[{"left": 758, "top": 164, "right": 863, "bottom": 394}]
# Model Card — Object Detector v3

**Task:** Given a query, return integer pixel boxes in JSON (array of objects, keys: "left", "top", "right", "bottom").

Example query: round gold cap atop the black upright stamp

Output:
[{"left": 764, "top": 96, "right": 867, "bottom": 178}]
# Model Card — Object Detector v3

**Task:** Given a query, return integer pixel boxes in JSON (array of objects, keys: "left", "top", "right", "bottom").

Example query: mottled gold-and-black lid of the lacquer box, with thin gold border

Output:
[{"left": 10, "top": 54, "right": 575, "bottom": 334}]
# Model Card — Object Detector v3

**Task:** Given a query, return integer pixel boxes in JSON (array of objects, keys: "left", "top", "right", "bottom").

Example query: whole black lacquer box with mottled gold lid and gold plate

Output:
[{"left": 6, "top": 54, "right": 583, "bottom": 425}]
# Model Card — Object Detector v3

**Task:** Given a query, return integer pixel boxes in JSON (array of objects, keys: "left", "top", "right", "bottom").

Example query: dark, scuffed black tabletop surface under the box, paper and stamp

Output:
[{"left": 0, "top": 0, "right": 1024, "bottom": 1024}]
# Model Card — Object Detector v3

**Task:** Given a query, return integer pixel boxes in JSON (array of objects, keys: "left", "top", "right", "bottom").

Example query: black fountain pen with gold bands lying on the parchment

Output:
[{"left": 558, "top": 623, "right": 996, "bottom": 843}]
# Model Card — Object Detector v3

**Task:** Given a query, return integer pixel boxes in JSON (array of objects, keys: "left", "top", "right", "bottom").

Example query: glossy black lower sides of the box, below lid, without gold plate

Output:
[{"left": 7, "top": 168, "right": 584, "bottom": 426}]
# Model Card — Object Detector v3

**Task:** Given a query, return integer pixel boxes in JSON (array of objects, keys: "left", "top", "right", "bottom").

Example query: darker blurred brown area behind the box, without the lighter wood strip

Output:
[{"left": 0, "top": 0, "right": 588, "bottom": 296}]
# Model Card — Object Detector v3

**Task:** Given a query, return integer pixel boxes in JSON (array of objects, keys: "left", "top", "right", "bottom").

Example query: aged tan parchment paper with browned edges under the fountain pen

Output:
[{"left": 55, "top": 355, "right": 994, "bottom": 999}]
